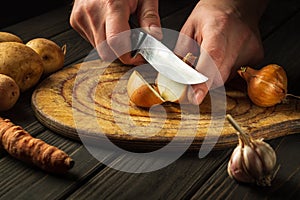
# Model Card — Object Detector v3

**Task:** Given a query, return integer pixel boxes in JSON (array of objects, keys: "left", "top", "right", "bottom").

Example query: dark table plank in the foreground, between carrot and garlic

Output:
[{"left": 69, "top": 152, "right": 231, "bottom": 199}]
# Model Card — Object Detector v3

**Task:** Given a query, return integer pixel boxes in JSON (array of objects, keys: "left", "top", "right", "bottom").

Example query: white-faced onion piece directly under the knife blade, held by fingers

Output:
[{"left": 156, "top": 73, "right": 188, "bottom": 103}]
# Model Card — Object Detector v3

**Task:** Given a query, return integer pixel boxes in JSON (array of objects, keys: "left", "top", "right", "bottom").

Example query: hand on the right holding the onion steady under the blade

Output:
[{"left": 174, "top": 0, "right": 266, "bottom": 104}]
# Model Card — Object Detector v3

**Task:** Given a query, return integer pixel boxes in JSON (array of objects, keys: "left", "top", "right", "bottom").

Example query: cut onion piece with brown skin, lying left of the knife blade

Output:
[{"left": 127, "top": 70, "right": 165, "bottom": 108}]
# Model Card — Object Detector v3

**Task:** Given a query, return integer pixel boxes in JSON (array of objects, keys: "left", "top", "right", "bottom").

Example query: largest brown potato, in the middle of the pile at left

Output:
[{"left": 0, "top": 42, "right": 44, "bottom": 92}]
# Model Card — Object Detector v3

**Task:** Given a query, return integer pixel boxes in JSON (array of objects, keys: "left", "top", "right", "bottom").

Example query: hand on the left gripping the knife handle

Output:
[{"left": 70, "top": 0, "right": 162, "bottom": 64}]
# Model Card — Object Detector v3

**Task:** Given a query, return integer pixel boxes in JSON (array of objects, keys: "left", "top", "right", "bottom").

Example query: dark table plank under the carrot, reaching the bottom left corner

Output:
[{"left": 0, "top": 131, "right": 113, "bottom": 199}]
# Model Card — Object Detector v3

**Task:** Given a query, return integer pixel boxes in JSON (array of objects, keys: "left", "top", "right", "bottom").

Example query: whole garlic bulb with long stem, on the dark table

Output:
[{"left": 227, "top": 115, "right": 276, "bottom": 186}]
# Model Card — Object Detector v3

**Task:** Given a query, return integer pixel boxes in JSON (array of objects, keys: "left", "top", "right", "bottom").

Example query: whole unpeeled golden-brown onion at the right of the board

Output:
[{"left": 238, "top": 64, "right": 287, "bottom": 107}]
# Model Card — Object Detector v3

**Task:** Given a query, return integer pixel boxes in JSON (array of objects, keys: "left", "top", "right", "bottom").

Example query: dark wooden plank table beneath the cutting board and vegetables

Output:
[{"left": 0, "top": 0, "right": 300, "bottom": 200}]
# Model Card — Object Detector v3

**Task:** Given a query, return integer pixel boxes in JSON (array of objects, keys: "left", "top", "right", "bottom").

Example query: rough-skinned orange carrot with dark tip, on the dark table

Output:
[{"left": 0, "top": 117, "right": 74, "bottom": 173}]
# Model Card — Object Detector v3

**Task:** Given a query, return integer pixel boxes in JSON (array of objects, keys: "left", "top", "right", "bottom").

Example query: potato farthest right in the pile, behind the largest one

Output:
[{"left": 26, "top": 38, "right": 66, "bottom": 75}]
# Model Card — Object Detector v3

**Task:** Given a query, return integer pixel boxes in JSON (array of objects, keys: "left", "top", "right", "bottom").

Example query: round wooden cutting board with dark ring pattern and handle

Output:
[{"left": 32, "top": 60, "right": 300, "bottom": 151}]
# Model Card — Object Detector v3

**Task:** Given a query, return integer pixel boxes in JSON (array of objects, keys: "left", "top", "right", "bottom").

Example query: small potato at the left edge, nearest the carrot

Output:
[{"left": 0, "top": 74, "right": 20, "bottom": 111}]
